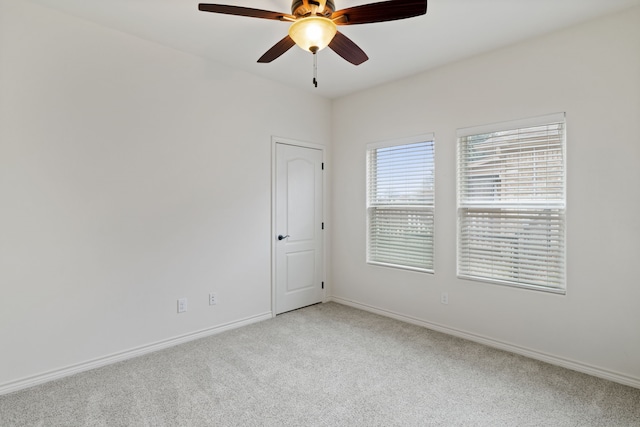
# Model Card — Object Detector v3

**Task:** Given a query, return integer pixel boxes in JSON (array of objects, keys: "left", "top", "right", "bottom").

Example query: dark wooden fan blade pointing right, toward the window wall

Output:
[{"left": 331, "top": 0, "right": 427, "bottom": 25}]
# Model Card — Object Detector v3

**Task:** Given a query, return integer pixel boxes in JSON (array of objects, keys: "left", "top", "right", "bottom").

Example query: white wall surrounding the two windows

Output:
[{"left": 331, "top": 8, "right": 640, "bottom": 386}]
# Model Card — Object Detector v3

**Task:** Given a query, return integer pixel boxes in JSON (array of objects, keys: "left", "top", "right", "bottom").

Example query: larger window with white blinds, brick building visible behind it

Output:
[{"left": 458, "top": 113, "right": 565, "bottom": 293}]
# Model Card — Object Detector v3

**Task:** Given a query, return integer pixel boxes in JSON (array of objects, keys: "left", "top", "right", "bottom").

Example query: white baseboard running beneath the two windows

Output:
[{"left": 328, "top": 296, "right": 640, "bottom": 389}]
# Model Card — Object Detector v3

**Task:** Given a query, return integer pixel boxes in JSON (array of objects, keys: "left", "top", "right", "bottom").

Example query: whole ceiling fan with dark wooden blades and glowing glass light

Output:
[{"left": 198, "top": 0, "right": 427, "bottom": 66}]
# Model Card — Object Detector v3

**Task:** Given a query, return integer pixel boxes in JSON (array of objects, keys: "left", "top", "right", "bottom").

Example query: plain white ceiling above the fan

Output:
[{"left": 31, "top": 0, "right": 640, "bottom": 98}]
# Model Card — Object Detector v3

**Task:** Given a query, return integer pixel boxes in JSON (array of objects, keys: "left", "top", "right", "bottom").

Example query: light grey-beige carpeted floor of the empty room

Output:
[{"left": 0, "top": 303, "right": 640, "bottom": 427}]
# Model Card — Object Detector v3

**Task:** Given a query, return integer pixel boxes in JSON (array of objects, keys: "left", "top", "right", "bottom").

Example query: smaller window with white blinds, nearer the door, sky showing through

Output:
[{"left": 367, "top": 135, "right": 434, "bottom": 272}]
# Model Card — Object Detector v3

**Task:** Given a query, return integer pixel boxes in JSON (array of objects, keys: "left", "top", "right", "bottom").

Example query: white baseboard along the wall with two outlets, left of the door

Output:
[{"left": 0, "top": 312, "right": 273, "bottom": 395}]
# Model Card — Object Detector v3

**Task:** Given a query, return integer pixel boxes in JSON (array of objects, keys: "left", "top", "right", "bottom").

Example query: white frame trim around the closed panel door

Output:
[{"left": 269, "top": 136, "right": 327, "bottom": 318}]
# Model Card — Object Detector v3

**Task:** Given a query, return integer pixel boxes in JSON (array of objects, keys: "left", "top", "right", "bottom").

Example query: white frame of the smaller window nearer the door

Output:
[{"left": 365, "top": 133, "right": 435, "bottom": 273}]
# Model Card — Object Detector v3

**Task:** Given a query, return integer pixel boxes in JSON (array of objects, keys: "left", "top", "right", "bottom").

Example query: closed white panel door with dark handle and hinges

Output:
[{"left": 273, "top": 143, "right": 324, "bottom": 314}]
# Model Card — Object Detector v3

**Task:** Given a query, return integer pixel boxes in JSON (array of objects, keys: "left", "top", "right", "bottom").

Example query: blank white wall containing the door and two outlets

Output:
[{"left": 0, "top": 0, "right": 330, "bottom": 389}]
